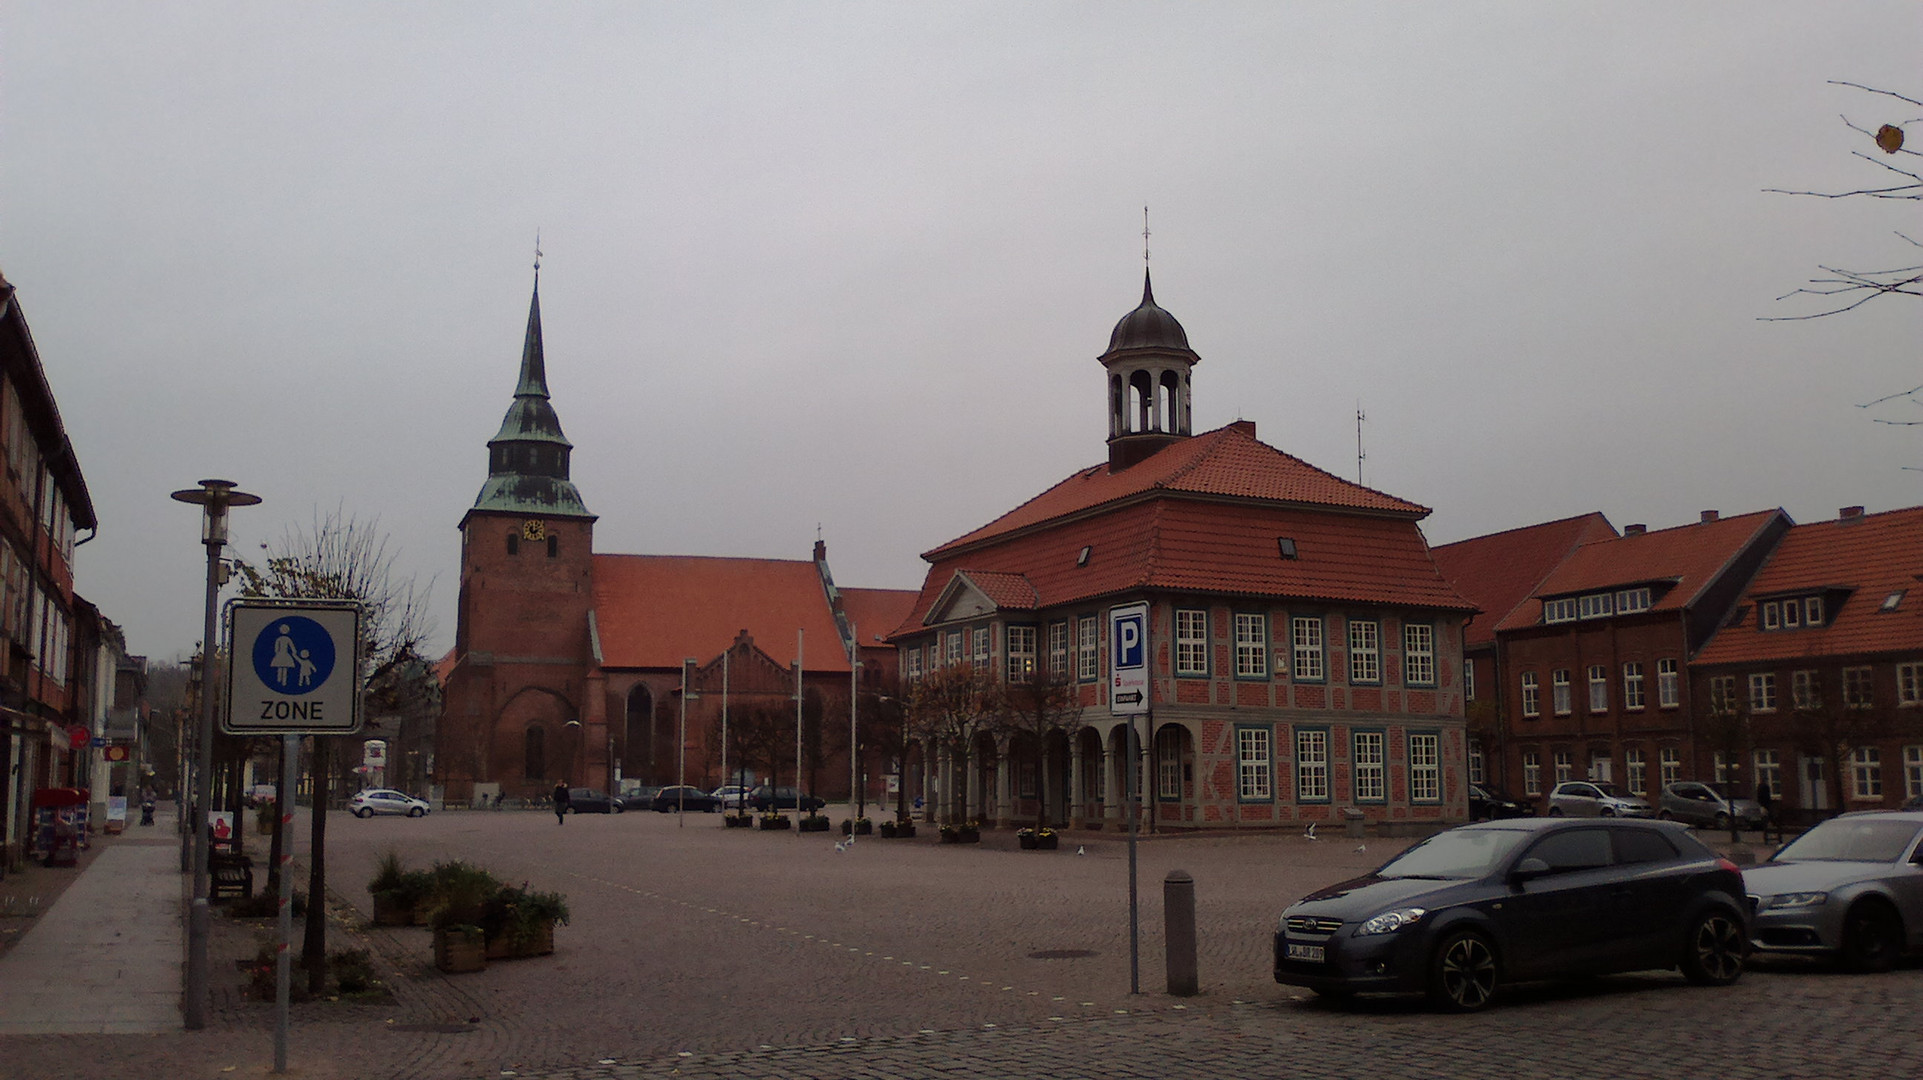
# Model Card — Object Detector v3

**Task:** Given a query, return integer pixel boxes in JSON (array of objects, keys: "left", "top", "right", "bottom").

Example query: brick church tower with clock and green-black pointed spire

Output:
[{"left": 437, "top": 267, "right": 606, "bottom": 799}]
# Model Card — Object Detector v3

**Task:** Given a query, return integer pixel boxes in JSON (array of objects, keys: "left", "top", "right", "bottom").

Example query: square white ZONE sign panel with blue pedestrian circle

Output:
[{"left": 221, "top": 600, "right": 362, "bottom": 734}]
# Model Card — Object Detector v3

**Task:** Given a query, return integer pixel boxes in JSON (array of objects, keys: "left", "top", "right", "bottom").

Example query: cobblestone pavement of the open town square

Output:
[{"left": 0, "top": 811, "right": 1923, "bottom": 1080}]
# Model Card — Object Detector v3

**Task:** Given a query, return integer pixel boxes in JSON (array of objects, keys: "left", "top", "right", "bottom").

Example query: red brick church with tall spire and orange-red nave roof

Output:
[{"left": 435, "top": 272, "right": 913, "bottom": 801}]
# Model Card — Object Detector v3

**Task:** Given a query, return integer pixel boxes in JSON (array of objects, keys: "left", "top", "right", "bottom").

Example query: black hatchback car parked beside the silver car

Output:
[{"left": 1275, "top": 819, "right": 1748, "bottom": 1013}]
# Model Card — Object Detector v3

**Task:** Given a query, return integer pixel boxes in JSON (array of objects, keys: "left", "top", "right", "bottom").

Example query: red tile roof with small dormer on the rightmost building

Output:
[{"left": 1696, "top": 507, "right": 1923, "bottom": 663}]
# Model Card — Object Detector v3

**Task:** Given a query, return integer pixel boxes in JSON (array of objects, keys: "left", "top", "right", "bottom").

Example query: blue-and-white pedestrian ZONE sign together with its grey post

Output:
[{"left": 221, "top": 600, "right": 361, "bottom": 1072}]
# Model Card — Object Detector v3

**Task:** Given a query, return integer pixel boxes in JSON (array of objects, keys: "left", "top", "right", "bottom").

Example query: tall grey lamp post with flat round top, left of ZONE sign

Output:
[{"left": 173, "top": 480, "right": 260, "bottom": 1032}]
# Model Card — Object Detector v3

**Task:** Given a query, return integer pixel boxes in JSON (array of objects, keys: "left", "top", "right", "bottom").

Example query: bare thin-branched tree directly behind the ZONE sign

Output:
[{"left": 235, "top": 509, "right": 433, "bottom": 994}]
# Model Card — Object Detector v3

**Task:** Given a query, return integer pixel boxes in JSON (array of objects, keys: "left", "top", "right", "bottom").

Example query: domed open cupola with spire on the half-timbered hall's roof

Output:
[{"left": 1098, "top": 269, "right": 1202, "bottom": 473}]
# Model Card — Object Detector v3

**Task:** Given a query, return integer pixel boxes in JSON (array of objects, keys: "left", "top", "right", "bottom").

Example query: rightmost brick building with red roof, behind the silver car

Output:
[{"left": 1690, "top": 505, "right": 1923, "bottom": 821}]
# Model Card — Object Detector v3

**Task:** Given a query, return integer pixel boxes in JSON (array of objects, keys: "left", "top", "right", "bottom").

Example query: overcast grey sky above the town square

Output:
[{"left": 0, "top": 0, "right": 1923, "bottom": 657}]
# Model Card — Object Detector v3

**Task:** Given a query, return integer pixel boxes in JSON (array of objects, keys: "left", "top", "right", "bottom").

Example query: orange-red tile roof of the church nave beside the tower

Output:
[{"left": 594, "top": 555, "right": 913, "bottom": 673}]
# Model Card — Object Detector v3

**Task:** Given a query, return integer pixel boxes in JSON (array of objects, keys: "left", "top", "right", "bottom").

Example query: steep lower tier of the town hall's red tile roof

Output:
[{"left": 896, "top": 499, "right": 1473, "bottom": 634}]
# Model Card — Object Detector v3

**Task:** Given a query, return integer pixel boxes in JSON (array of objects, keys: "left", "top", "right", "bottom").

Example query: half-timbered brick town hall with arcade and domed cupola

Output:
[{"left": 890, "top": 272, "right": 1473, "bottom": 828}]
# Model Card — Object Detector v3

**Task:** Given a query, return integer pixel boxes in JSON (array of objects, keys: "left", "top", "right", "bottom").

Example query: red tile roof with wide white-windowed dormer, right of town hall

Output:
[{"left": 1496, "top": 509, "right": 1788, "bottom": 630}]
